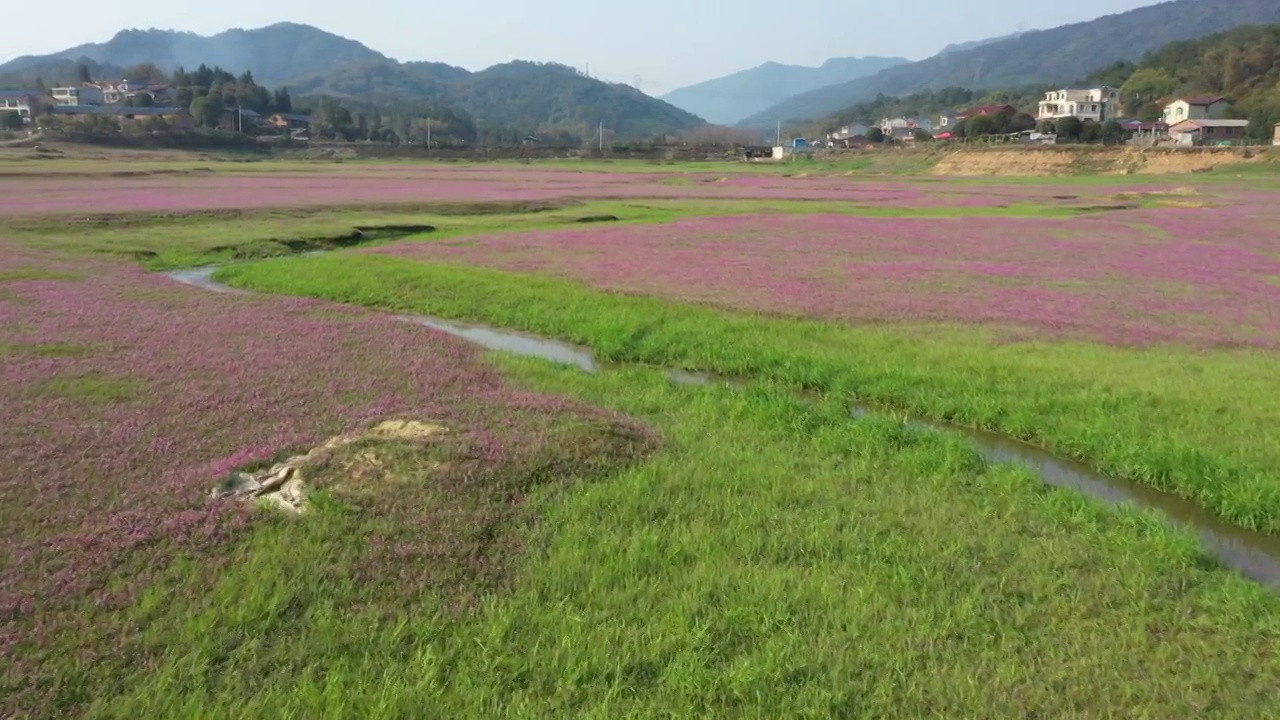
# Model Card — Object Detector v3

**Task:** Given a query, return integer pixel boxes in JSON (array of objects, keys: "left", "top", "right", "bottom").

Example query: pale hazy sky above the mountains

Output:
[{"left": 0, "top": 0, "right": 1156, "bottom": 95}]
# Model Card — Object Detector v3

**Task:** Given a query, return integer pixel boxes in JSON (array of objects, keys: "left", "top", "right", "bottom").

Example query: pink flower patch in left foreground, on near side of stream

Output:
[{"left": 0, "top": 242, "right": 648, "bottom": 716}]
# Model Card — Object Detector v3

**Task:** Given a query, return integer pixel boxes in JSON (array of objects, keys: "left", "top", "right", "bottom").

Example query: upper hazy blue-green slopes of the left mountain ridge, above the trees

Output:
[{"left": 0, "top": 23, "right": 704, "bottom": 138}]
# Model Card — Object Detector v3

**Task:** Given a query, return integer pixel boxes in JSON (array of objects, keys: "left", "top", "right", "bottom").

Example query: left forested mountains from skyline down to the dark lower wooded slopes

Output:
[{"left": 0, "top": 23, "right": 705, "bottom": 145}]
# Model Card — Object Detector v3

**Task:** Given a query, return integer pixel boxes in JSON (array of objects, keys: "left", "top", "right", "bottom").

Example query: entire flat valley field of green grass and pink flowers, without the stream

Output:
[{"left": 0, "top": 158, "right": 1280, "bottom": 717}]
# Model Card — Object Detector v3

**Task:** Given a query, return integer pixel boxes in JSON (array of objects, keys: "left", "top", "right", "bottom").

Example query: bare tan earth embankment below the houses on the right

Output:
[{"left": 932, "top": 147, "right": 1280, "bottom": 176}]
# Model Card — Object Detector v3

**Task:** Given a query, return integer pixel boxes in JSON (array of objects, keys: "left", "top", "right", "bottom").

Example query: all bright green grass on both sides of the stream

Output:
[{"left": 0, "top": 159, "right": 1280, "bottom": 720}]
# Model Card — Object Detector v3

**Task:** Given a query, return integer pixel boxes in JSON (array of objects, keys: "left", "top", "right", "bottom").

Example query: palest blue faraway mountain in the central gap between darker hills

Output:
[{"left": 662, "top": 56, "right": 909, "bottom": 124}]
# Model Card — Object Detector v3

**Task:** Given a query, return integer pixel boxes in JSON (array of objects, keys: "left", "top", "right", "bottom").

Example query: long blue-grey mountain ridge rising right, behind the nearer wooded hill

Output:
[{"left": 739, "top": 0, "right": 1280, "bottom": 129}]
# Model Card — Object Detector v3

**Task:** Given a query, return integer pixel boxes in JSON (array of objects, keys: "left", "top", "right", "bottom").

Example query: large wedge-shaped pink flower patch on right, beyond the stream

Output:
[{"left": 376, "top": 204, "right": 1280, "bottom": 347}]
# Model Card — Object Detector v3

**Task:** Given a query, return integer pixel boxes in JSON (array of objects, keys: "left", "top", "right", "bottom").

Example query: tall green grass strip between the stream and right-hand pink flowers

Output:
[{"left": 225, "top": 255, "right": 1280, "bottom": 533}]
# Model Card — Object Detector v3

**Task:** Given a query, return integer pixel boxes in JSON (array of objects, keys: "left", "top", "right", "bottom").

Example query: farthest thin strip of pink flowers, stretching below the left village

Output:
[{"left": 0, "top": 167, "right": 1162, "bottom": 215}]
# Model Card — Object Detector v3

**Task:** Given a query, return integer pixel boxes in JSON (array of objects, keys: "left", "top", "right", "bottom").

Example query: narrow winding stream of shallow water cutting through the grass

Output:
[{"left": 165, "top": 260, "right": 1280, "bottom": 591}]
